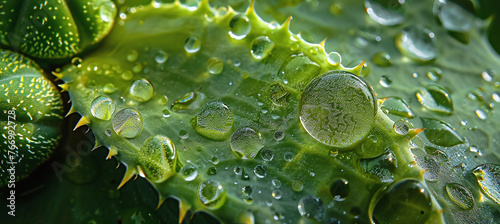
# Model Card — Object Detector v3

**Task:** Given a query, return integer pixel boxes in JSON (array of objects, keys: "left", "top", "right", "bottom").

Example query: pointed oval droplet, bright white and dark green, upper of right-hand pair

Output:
[{"left": 417, "top": 85, "right": 453, "bottom": 115}]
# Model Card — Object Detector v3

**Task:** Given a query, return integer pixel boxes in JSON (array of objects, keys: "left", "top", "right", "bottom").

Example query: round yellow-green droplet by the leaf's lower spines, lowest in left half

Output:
[{"left": 198, "top": 180, "right": 226, "bottom": 209}]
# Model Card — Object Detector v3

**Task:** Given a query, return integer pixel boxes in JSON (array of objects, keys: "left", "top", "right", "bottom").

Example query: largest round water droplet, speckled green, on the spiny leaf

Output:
[{"left": 299, "top": 71, "right": 377, "bottom": 148}]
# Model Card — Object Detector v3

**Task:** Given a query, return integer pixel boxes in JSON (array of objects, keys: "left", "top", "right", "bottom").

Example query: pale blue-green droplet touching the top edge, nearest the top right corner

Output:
[{"left": 437, "top": 1, "right": 475, "bottom": 32}]
